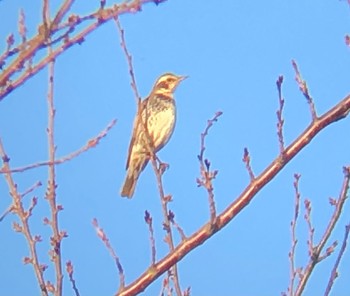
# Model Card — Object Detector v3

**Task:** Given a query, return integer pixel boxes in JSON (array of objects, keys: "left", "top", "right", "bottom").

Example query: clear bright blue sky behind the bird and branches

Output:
[{"left": 0, "top": 0, "right": 350, "bottom": 296}]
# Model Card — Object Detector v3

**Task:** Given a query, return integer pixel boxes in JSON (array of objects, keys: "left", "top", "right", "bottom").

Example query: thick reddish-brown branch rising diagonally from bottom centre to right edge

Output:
[{"left": 119, "top": 95, "right": 350, "bottom": 296}]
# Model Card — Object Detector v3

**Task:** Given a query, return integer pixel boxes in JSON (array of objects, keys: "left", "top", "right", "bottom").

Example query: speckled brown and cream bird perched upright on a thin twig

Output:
[{"left": 120, "top": 73, "right": 187, "bottom": 198}]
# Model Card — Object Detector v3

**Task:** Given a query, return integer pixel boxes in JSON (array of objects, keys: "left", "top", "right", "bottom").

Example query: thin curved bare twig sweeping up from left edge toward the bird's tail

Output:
[{"left": 0, "top": 119, "right": 117, "bottom": 174}]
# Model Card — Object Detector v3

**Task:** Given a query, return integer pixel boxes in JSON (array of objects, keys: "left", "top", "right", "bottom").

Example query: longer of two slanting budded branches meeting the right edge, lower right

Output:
[{"left": 295, "top": 166, "right": 350, "bottom": 296}]
